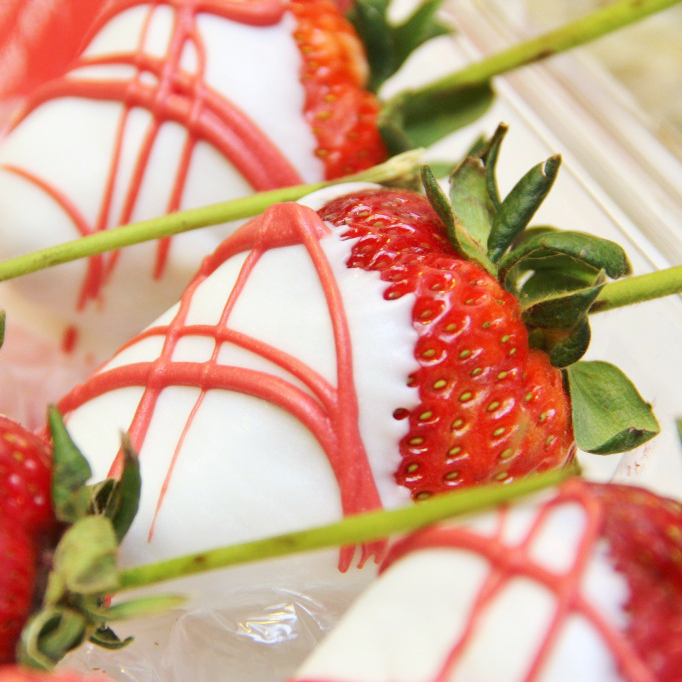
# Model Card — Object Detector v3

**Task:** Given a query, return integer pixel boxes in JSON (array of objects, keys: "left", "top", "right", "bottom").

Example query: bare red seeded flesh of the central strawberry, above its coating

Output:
[{"left": 320, "top": 183, "right": 574, "bottom": 499}]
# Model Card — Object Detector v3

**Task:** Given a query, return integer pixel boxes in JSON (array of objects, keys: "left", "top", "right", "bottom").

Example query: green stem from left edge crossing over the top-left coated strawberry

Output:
[{"left": 0, "top": 149, "right": 422, "bottom": 282}]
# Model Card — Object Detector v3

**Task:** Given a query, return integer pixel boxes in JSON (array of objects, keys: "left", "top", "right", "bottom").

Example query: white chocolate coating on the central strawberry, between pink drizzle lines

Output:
[{"left": 68, "top": 186, "right": 416, "bottom": 603}]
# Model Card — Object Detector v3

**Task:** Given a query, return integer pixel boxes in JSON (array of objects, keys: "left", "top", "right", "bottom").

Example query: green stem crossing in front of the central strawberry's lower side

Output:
[{"left": 120, "top": 469, "right": 575, "bottom": 590}]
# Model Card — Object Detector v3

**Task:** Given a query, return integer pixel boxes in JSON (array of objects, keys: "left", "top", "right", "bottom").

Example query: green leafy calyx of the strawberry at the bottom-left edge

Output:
[{"left": 17, "top": 407, "right": 180, "bottom": 670}]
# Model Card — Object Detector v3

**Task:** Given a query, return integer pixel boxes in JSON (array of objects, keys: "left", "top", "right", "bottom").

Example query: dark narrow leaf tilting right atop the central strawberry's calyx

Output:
[{"left": 488, "top": 156, "right": 561, "bottom": 263}]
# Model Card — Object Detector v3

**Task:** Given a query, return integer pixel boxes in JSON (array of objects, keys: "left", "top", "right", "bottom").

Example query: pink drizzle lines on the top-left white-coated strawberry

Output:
[{"left": 3, "top": 0, "right": 302, "bottom": 330}]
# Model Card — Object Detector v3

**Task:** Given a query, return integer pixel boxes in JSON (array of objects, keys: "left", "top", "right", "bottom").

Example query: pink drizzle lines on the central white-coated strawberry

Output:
[{"left": 59, "top": 204, "right": 386, "bottom": 571}]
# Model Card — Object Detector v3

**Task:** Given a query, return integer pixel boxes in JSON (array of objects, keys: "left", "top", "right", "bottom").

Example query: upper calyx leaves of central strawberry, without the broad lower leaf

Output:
[{"left": 422, "top": 125, "right": 630, "bottom": 367}]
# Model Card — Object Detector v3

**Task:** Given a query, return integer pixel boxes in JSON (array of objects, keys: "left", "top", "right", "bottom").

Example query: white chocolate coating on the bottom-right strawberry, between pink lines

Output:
[{"left": 292, "top": 494, "right": 628, "bottom": 682}]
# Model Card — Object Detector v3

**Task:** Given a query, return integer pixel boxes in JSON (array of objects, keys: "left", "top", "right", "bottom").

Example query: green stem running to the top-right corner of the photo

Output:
[{"left": 390, "top": 0, "right": 680, "bottom": 103}]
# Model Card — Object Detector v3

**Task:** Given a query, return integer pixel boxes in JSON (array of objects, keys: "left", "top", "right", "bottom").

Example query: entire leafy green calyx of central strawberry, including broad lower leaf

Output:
[{"left": 422, "top": 125, "right": 660, "bottom": 454}]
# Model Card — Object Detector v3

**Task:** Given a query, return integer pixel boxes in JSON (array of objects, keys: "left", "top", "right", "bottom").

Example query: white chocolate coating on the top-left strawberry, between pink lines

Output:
[{"left": 0, "top": 4, "right": 323, "bottom": 359}]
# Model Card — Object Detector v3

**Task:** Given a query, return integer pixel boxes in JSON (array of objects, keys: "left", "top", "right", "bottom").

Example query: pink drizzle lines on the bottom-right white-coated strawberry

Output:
[{"left": 292, "top": 480, "right": 656, "bottom": 682}]
